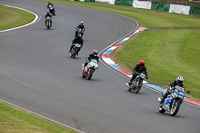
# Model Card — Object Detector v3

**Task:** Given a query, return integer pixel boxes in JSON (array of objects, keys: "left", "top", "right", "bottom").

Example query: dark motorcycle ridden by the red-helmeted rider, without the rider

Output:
[{"left": 126, "top": 73, "right": 145, "bottom": 94}]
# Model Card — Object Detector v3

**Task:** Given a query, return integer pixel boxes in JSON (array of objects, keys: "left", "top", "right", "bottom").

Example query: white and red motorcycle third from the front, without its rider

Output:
[{"left": 82, "top": 59, "right": 99, "bottom": 80}]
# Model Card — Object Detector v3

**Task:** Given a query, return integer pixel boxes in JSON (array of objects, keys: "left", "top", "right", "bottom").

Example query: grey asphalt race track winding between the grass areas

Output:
[{"left": 0, "top": 0, "right": 200, "bottom": 133}]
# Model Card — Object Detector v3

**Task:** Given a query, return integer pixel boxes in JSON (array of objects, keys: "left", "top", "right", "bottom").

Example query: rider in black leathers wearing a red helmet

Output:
[{"left": 129, "top": 60, "right": 148, "bottom": 86}]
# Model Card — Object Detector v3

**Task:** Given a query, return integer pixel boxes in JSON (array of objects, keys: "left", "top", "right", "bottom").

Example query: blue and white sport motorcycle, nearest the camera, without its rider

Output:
[{"left": 158, "top": 85, "right": 190, "bottom": 116}]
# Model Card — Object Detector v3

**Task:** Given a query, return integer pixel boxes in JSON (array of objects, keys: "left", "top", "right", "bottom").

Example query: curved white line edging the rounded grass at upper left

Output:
[{"left": 0, "top": 5, "right": 40, "bottom": 32}]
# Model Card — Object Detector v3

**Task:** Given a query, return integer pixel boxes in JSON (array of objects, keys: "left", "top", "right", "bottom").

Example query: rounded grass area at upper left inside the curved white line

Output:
[{"left": 0, "top": 5, "right": 35, "bottom": 31}]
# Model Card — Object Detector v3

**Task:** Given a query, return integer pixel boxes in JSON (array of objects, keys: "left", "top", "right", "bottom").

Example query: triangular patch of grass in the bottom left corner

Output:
[{"left": 0, "top": 102, "right": 75, "bottom": 133}]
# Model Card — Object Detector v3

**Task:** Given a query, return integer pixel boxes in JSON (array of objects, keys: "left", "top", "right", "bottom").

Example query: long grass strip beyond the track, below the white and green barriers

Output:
[{"left": 39, "top": 0, "right": 200, "bottom": 27}]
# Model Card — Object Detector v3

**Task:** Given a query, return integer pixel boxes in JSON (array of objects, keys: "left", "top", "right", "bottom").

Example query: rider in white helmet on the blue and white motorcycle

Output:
[{"left": 160, "top": 76, "right": 185, "bottom": 103}]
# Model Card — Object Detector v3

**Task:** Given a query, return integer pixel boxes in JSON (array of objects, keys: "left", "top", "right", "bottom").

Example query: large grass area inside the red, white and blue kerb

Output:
[{"left": 116, "top": 30, "right": 200, "bottom": 98}]
